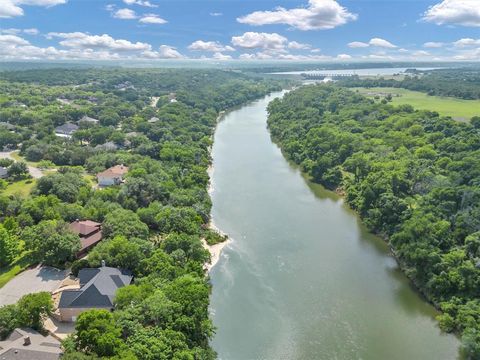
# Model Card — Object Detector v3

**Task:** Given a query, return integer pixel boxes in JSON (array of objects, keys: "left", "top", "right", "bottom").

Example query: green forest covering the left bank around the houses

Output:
[{"left": 0, "top": 69, "right": 283, "bottom": 360}]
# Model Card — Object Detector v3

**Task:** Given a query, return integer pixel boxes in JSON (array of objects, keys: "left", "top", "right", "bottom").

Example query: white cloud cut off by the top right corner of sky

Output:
[{"left": 422, "top": 0, "right": 480, "bottom": 27}]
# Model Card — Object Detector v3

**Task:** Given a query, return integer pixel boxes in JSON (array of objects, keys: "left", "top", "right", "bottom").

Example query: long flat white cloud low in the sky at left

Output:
[{"left": 47, "top": 32, "right": 152, "bottom": 51}]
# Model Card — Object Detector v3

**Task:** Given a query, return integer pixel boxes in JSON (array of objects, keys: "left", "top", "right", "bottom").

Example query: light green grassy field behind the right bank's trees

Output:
[{"left": 352, "top": 88, "right": 480, "bottom": 121}]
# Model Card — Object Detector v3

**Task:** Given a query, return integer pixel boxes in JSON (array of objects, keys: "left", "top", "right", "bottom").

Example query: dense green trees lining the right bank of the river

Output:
[{"left": 268, "top": 85, "right": 480, "bottom": 359}]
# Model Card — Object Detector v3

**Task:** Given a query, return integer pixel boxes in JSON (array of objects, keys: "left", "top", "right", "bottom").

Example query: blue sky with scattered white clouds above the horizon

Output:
[{"left": 0, "top": 0, "right": 480, "bottom": 61}]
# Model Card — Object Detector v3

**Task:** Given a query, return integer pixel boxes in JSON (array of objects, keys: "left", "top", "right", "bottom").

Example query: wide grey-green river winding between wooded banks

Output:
[{"left": 210, "top": 92, "right": 459, "bottom": 360}]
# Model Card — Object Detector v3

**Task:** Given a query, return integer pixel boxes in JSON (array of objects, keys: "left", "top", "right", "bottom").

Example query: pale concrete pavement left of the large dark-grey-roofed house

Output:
[{"left": 0, "top": 266, "right": 68, "bottom": 306}]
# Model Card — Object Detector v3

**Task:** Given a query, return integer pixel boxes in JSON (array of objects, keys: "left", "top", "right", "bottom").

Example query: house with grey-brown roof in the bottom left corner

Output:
[{"left": 0, "top": 328, "right": 62, "bottom": 360}]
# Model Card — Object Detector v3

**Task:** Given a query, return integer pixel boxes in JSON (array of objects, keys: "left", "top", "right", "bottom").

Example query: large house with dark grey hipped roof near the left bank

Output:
[{"left": 58, "top": 266, "right": 133, "bottom": 322}]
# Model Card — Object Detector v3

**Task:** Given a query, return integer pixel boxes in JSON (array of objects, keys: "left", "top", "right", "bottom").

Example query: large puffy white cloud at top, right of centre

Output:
[{"left": 237, "top": 0, "right": 358, "bottom": 30}]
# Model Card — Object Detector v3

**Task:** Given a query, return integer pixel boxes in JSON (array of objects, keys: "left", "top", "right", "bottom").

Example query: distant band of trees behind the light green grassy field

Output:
[{"left": 339, "top": 68, "right": 480, "bottom": 100}]
